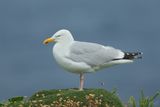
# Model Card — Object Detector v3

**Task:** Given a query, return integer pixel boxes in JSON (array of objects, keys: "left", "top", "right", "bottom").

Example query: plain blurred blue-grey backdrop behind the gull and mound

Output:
[{"left": 0, "top": 0, "right": 160, "bottom": 102}]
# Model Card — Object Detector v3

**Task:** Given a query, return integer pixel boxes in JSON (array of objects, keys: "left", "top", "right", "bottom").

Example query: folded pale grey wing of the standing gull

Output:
[{"left": 67, "top": 41, "right": 124, "bottom": 66}]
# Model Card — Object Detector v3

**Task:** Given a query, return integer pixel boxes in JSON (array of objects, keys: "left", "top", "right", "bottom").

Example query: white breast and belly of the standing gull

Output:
[{"left": 53, "top": 45, "right": 93, "bottom": 73}]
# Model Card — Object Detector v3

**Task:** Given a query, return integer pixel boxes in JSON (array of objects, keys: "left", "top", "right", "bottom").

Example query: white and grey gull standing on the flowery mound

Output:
[{"left": 43, "top": 29, "right": 142, "bottom": 90}]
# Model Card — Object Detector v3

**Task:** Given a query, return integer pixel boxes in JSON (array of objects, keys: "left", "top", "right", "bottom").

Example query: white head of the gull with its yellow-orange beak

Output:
[{"left": 43, "top": 29, "right": 74, "bottom": 45}]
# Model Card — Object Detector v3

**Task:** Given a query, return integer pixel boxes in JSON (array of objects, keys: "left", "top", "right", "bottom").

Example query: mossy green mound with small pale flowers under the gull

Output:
[{"left": 0, "top": 89, "right": 123, "bottom": 107}]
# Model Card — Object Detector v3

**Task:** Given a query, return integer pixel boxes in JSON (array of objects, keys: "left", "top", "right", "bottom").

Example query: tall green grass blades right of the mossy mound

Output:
[{"left": 128, "top": 90, "right": 160, "bottom": 107}]
